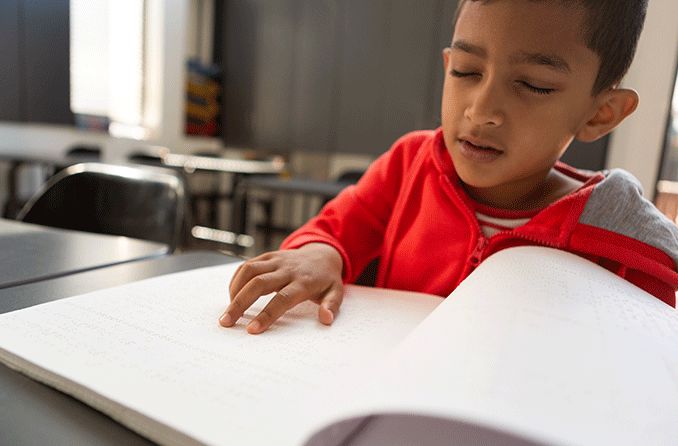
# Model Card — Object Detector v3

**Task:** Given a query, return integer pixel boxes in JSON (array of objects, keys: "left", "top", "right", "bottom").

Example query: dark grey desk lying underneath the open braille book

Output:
[{"left": 0, "top": 252, "right": 237, "bottom": 446}]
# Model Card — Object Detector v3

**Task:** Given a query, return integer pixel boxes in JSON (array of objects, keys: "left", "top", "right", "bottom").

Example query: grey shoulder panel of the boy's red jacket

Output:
[{"left": 579, "top": 169, "right": 678, "bottom": 264}]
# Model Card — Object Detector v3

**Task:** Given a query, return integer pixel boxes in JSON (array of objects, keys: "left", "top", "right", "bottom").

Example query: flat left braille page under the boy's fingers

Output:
[{"left": 0, "top": 264, "right": 442, "bottom": 445}]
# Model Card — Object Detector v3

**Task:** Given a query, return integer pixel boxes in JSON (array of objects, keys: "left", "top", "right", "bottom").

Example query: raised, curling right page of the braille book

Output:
[{"left": 309, "top": 247, "right": 678, "bottom": 445}]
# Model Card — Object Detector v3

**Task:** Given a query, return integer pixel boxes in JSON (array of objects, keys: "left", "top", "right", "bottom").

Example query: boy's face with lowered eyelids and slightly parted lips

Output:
[{"left": 442, "top": 0, "right": 599, "bottom": 205}]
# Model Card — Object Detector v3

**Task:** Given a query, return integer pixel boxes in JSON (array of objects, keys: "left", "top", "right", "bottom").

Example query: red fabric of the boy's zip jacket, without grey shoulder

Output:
[{"left": 282, "top": 130, "right": 678, "bottom": 306}]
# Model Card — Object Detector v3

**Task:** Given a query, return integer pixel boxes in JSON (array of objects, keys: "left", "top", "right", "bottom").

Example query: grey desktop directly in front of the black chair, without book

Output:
[{"left": 0, "top": 219, "right": 167, "bottom": 289}]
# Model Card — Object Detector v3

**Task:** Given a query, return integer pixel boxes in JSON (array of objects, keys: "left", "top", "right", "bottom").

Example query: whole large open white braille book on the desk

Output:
[{"left": 0, "top": 247, "right": 678, "bottom": 445}]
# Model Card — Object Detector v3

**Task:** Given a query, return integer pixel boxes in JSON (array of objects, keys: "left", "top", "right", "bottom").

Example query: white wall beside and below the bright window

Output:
[{"left": 0, "top": 0, "right": 222, "bottom": 166}]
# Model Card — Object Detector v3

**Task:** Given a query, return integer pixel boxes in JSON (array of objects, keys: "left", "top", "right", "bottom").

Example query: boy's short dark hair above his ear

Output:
[{"left": 454, "top": 0, "right": 648, "bottom": 95}]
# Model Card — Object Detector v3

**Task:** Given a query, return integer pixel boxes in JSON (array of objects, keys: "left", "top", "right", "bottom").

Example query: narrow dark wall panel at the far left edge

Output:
[{"left": 0, "top": 0, "right": 21, "bottom": 121}]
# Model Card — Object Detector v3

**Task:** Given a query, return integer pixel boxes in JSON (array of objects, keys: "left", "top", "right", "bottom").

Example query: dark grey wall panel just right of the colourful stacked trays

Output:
[{"left": 222, "top": 0, "right": 301, "bottom": 150}]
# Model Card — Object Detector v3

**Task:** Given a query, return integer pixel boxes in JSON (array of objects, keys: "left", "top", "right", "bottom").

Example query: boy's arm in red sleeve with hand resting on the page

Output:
[{"left": 220, "top": 132, "right": 430, "bottom": 333}]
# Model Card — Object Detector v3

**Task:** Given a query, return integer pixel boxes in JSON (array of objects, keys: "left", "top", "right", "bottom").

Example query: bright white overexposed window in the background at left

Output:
[{"left": 70, "top": 0, "right": 145, "bottom": 139}]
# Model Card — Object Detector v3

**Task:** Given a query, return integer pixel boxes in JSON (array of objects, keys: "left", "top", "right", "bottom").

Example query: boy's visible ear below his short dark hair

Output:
[{"left": 575, "top": 88, "right": 638, "bottom": 142}]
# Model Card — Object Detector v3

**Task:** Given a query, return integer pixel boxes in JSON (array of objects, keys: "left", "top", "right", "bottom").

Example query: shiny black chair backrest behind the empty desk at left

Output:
[{"left": 17, "top": 163, "right": 186, "bottom": 252}]
